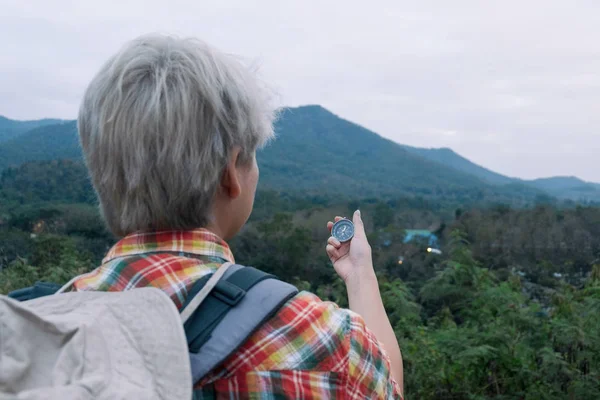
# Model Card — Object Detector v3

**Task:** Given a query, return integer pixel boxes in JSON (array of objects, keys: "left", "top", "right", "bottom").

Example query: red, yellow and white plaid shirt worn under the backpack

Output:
[{"left": 74, "top": 229, "right": 401, "bottom": 400}]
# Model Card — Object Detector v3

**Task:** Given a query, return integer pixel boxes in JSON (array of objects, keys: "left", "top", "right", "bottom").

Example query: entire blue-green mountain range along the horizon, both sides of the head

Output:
[{"left": 0, "top": 105, "right": 600, "bottom": 203}]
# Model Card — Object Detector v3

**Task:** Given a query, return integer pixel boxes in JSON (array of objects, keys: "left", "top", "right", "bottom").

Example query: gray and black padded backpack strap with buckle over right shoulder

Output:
[{"left": 182, "top": 265, "right": 298, "bottom": 382}]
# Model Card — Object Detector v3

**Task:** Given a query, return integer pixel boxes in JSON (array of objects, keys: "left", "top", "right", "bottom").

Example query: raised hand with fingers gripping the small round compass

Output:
[{"left": 325, "top": 210, "right": 373, "bottom": 284}]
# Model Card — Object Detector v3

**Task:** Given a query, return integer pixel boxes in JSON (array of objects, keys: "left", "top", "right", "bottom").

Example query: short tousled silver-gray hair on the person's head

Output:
[{"left": 78, "top": 35, "right": 275, "bottom": 236}]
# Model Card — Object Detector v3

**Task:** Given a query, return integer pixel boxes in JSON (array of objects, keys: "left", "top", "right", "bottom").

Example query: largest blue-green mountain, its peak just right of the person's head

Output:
[{"left": 259, "top": 106, "right": 540, "bottom": 201}]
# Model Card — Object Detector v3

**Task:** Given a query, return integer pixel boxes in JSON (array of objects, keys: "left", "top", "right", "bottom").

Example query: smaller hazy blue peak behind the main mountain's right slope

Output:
[{"left": 403, "top": 146, "right": 517, "bottom": 185}]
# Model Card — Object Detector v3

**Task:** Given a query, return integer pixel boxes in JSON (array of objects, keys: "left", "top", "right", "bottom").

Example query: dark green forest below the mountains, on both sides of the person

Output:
[{"left": 0, "top": 161, "right": 600, "bottom": 399}]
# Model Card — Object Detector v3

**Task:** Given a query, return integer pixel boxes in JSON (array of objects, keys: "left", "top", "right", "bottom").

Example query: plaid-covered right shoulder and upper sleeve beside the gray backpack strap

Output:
[{"left": 202, "top": 292, "right": 401, "bottom": 399}]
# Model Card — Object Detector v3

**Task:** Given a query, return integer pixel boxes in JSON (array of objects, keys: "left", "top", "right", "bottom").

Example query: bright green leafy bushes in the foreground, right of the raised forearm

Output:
[{"left": 400, "top": 234, "right": 600, "bottom": 399}]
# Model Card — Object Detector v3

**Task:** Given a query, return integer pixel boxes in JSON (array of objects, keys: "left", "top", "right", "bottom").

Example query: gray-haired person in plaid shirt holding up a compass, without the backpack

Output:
[{"left": 72, "top": 35, "right": 403, "bottom": 399}]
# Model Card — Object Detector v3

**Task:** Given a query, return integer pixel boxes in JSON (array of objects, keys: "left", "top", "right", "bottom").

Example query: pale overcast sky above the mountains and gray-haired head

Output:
[{"left": 0, "top": 0, "right": 600, "bottom": 182}]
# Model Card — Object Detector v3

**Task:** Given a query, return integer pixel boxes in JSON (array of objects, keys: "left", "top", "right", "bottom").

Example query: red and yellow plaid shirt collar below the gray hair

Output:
[{"left": 102, "top": 228, "right": 235, "bottom": 264}]
